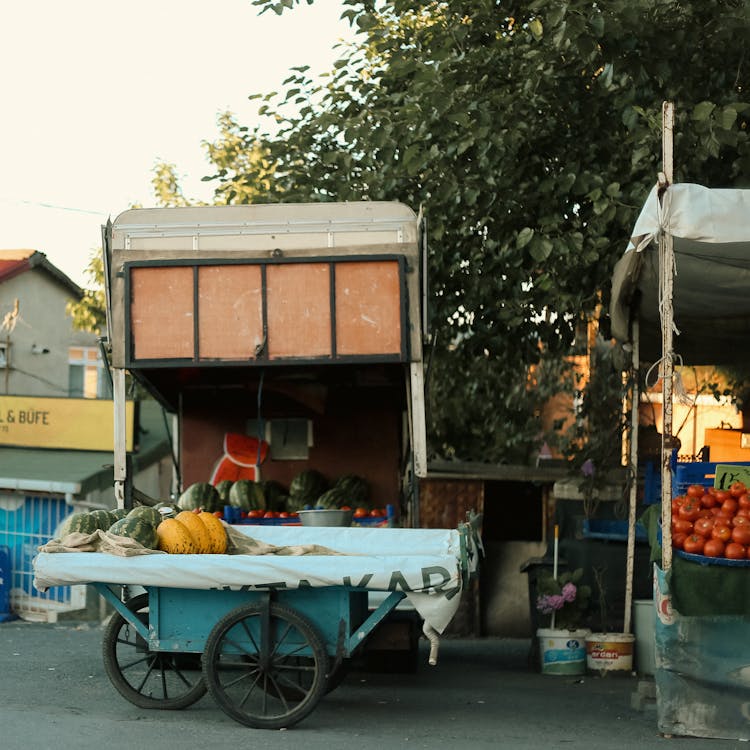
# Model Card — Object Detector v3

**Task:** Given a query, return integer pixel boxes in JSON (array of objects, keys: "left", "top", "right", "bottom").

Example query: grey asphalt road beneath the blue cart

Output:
[{"left": 0, "top": 620, "right": 748, "bottom": 750}]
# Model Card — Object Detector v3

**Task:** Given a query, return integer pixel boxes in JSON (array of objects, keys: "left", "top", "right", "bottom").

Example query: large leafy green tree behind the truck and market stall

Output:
[{"left": 156, "top": 0, "right": 750, "bottom": 462}]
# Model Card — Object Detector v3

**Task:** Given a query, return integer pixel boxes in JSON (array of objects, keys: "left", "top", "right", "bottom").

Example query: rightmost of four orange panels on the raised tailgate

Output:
[{"left": 336, "top": 260, "right": 401, "bottom": 355}]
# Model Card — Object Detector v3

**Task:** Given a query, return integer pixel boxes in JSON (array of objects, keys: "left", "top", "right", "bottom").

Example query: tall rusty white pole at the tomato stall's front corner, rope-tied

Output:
[{"left": 659, "top": 102, "right": 674, "bottom": 572}]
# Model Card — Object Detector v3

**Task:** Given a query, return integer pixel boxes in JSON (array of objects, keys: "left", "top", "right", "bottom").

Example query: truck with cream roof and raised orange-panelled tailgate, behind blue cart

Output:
[{"left": 102, "top": 201, "right": 427, "bottom": 527}]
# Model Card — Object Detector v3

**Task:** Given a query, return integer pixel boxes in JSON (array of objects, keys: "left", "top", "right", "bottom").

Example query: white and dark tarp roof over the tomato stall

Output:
[{"left": 610, "top": 183, "right": 750, "bottom": 365}]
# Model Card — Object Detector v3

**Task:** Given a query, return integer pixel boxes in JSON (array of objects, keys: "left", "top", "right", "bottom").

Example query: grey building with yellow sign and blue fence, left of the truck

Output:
[{"left": 0, "top": 250, "right": 173, "bottom": 622}]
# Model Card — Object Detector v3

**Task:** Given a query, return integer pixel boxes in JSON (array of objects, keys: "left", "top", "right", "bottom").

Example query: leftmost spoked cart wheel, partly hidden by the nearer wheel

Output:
[{"left": 102, "top": 594, "right": 206, "bottom": 709}]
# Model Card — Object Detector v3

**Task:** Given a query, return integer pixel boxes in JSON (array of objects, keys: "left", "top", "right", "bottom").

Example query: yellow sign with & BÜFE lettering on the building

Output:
[{"left": 0, "top": 396, "right": 135, "bottom": 452}]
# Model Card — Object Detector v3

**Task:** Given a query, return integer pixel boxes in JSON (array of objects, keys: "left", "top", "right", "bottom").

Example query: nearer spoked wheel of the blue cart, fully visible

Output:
[{"left": 203, "top": 603, "right": 328, "bottom": 729}]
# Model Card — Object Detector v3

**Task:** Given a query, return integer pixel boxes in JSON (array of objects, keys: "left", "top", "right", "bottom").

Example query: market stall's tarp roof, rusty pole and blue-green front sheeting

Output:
[{"left": 610, "top": 111, "right": 750, "bottom": 740}]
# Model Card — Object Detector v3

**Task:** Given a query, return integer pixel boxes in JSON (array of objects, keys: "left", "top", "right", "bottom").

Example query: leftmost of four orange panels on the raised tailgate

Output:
[{"left": 130, "top": 266, "right": 194, "bottom": 359}]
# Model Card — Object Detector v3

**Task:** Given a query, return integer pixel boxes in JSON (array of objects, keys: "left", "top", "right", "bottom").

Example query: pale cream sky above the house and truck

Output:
[{"left": 0, "top": 0, "right": 354, "bottom": 286}]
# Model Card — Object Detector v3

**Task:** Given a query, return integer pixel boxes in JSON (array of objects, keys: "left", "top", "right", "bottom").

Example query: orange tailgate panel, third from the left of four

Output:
[{"left": 266, "top": 263, "right": 331, "bottom": 359}]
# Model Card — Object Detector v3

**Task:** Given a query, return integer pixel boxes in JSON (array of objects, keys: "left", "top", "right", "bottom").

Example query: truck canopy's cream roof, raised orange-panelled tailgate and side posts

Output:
[{"left": 103, "top": 201, "right": 426, "bottom": 505}]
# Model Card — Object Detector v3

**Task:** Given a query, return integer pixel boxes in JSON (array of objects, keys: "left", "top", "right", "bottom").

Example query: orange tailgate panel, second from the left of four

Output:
[{"left": 198, "top": 265, "right": 263, "bottom": 359}]
